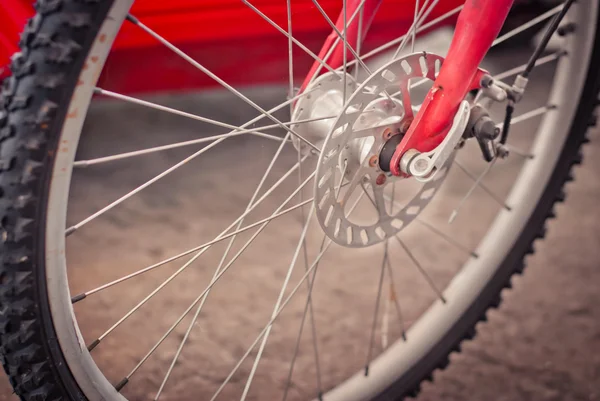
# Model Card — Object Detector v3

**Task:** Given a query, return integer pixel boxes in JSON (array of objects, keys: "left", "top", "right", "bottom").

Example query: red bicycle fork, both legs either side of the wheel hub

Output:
[{"left": 302, "top": 0, "right": 514, "bottom": 175}]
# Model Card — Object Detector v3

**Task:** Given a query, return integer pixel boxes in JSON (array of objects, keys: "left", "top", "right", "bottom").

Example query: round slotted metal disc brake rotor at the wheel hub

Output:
[{"left": 314, "top": 53, "right": 453, "bottom": 247}]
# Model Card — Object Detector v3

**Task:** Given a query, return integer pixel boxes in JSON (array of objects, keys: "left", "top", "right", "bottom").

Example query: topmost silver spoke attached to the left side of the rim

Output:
[{"left": 127, "top": 14, "right": 321, "bottom": 152}]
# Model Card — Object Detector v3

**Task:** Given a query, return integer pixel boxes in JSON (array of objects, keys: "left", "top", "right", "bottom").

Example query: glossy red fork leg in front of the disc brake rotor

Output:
[{"left": 390, "top": 0, "right": 514, "bottom": 175}]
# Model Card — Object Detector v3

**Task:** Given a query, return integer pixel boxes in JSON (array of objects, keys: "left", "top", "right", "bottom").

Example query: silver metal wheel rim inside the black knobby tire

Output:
[{"left": 45, "top": 0, "right": 598, "bottom": 401}]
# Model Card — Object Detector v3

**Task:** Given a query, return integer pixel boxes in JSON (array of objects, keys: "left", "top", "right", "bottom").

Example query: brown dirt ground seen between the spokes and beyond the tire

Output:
[{"left": 0, "top": 48, "right": 600, "bottom": 401}]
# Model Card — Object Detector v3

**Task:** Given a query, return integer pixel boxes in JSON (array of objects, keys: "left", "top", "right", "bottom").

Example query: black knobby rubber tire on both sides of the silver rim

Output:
[{"left": 0, "top": 0, "right": 600, "bottom": 401}]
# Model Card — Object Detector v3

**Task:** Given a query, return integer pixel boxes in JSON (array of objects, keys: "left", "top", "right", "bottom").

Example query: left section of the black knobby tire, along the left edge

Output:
[{"left": 0, "top": 0, "right": 112, "bottom": 401}]
